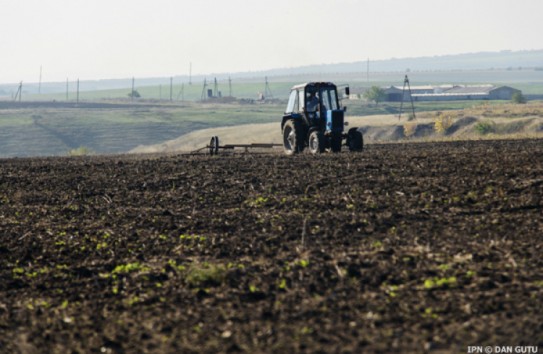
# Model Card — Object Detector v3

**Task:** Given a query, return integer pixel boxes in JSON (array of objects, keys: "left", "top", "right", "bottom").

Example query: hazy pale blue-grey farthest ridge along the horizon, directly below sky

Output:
[{"left": 0, "top": 49, "right": 543, "bottom": 97}]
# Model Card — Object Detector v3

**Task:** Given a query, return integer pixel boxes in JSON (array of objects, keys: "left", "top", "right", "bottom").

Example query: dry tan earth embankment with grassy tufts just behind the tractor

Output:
[{"left": 130, "top": 114, "right": 543, "bottom": 153}]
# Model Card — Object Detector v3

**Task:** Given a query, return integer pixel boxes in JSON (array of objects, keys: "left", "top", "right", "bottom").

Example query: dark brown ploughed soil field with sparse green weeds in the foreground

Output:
[{"left": 0, "top": 140, "right": 543, "bottom": 353}]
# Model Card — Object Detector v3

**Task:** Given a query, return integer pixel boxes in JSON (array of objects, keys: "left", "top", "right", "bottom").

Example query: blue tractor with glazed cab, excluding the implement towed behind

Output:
[{"left": 281, "top": 82, "right": 364, "bottom": 155}]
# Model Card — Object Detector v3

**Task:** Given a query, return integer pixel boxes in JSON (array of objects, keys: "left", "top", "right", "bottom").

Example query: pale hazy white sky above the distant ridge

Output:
[{"left": 0, "top": 0, "right": 543, "bottom": 83}]
